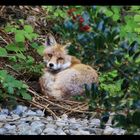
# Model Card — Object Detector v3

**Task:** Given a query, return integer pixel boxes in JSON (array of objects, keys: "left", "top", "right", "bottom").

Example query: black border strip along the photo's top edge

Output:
[{"left": 0, "top": 0, "right": 140, "bottom": 5}]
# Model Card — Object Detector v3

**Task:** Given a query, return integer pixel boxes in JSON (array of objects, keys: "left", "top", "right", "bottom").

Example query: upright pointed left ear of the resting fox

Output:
[{"left": 44, "top": 33, "right": 57, "bottom": 47}]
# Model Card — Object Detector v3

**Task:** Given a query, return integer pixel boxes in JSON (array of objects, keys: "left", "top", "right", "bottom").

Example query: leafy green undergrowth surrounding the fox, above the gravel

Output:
[{"left": 0, "top": 6, "right": 140, "bottom": 134}]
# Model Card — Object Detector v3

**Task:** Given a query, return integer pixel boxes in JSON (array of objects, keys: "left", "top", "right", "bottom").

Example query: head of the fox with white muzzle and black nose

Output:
[{"left": 43, "top": 34, "right": 72, "bottom": 71}]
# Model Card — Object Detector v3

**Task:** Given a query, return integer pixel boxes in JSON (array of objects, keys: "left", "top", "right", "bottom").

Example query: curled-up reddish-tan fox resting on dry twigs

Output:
[{"left": 39, "top": 34, "right": 98, "bottom": 100}]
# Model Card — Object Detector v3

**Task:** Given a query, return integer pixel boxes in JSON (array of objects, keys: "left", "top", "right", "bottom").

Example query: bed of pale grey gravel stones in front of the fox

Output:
[{"left": 0, "top": 105, "right": 126, "bottom": 135}]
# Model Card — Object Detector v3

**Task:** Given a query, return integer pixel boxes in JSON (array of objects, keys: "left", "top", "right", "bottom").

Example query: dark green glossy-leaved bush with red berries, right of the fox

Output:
[{"left": 45, "top": 6, "right": 140, "bottom": 133}]
